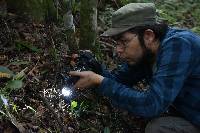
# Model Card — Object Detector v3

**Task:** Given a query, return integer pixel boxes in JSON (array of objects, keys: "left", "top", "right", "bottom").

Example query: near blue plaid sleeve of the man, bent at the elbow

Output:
[{"left": 98, "top": 37, "right": 192, "bottom": 117}]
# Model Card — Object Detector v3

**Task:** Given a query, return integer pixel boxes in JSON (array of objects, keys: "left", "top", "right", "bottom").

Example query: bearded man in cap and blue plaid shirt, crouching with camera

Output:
[{"left": 70, "top": 3, "right": 200, "bottom": 133}]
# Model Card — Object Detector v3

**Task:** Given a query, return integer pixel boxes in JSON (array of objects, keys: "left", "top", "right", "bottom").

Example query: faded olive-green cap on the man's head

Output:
[{"left": 101, "top": 3, "right": 157, "bottom": 37}]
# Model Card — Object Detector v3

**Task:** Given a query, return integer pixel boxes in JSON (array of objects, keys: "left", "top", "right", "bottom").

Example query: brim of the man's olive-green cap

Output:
[{"left": 100, "top": 27, "right": 131, "bottom": 37}]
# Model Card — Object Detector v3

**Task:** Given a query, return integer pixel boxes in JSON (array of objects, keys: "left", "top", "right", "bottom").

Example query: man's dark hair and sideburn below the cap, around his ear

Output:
[{"left": 128, "top": 23, "right": 168, "bottom": 47}]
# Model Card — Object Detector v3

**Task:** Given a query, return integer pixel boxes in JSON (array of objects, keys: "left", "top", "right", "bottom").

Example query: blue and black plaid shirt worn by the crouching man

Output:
[{"left": 98, "top": 28, "right": 200, "bottom": 126}]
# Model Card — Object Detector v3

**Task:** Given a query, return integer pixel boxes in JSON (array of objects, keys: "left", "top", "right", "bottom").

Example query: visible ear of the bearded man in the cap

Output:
[{"left": 144, "top": 29, "right": 155, "bottom": 47}]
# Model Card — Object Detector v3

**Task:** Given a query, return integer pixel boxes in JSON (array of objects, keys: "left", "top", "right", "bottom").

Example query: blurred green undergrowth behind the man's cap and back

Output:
[{"left": 116, "top": 0, "right": 200, "bottom": 33}]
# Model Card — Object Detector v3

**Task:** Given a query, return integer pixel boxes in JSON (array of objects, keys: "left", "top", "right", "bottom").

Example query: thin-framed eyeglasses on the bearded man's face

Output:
[{"left": 114, "top": 34, "right": 137, "bottom": 49}]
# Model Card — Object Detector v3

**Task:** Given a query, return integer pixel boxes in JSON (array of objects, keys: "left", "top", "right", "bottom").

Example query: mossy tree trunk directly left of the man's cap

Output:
[{"left": 79, "top": 0, "right": 98, "bottom": 50}]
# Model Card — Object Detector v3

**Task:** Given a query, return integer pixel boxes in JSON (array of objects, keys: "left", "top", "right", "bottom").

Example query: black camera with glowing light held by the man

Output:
[{"left": 61, "top": 51, "right": 102, "bottom": 100}]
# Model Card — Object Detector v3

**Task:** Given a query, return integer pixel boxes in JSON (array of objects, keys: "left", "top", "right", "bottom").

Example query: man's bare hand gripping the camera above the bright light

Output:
[{"left": 69, "top": 71, "right": 104, "bottom": 89}]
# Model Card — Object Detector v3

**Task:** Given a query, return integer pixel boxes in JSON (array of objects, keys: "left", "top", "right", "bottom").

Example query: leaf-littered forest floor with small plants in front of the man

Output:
[{"left": 0, "top": 14, "right": 145, "bottom": 133}]
